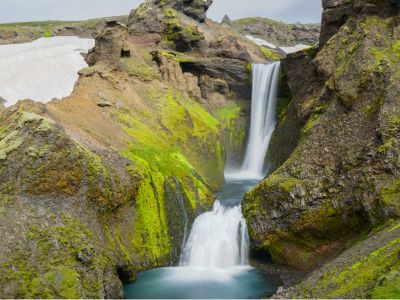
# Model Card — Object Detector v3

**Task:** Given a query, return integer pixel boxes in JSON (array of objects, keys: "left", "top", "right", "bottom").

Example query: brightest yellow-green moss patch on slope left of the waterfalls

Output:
[{"left": 114, "top": 86, "right": 227, "bottom": 265}]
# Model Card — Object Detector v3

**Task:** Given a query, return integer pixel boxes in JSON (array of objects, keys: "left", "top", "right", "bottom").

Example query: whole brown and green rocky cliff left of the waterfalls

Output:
[{"left": 0, "top": 1, "right": 276, "bottom": 298}]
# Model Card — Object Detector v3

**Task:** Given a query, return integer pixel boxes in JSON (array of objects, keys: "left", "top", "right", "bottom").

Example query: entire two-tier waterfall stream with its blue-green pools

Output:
[{"left": 124, "top": 63, "right": 280, "bottom": 299}]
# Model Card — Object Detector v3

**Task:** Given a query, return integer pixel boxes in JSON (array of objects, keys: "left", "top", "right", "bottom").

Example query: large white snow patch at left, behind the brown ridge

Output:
[{"left": 0, "top": 37, "right": 94, "bottom": 107}]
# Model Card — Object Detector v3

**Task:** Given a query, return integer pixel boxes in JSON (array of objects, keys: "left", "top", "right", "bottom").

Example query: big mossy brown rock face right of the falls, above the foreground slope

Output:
[{"left": 244, "top": 2, "right": 400, "bottom": 282}]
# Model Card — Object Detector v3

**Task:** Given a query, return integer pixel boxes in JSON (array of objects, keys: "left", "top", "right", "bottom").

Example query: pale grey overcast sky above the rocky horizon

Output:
[{"left": 0, "top": 0, "right": 322, "bottom": 23}]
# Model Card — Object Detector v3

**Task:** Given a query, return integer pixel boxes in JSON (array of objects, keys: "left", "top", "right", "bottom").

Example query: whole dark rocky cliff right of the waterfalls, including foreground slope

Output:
[{"left": 244, "top": 0, "right": 400, "bottom": 298}]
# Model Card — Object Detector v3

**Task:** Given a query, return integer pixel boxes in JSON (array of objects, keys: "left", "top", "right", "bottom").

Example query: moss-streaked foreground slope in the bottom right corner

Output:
[{"left": 287, "top": 222, "right": 400, "bottom": 299}]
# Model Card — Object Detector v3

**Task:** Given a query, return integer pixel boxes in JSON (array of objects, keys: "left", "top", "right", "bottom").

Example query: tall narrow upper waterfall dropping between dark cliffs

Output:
[{"left": 234, "top": 62, "right": 280, "bottom": 179}]
